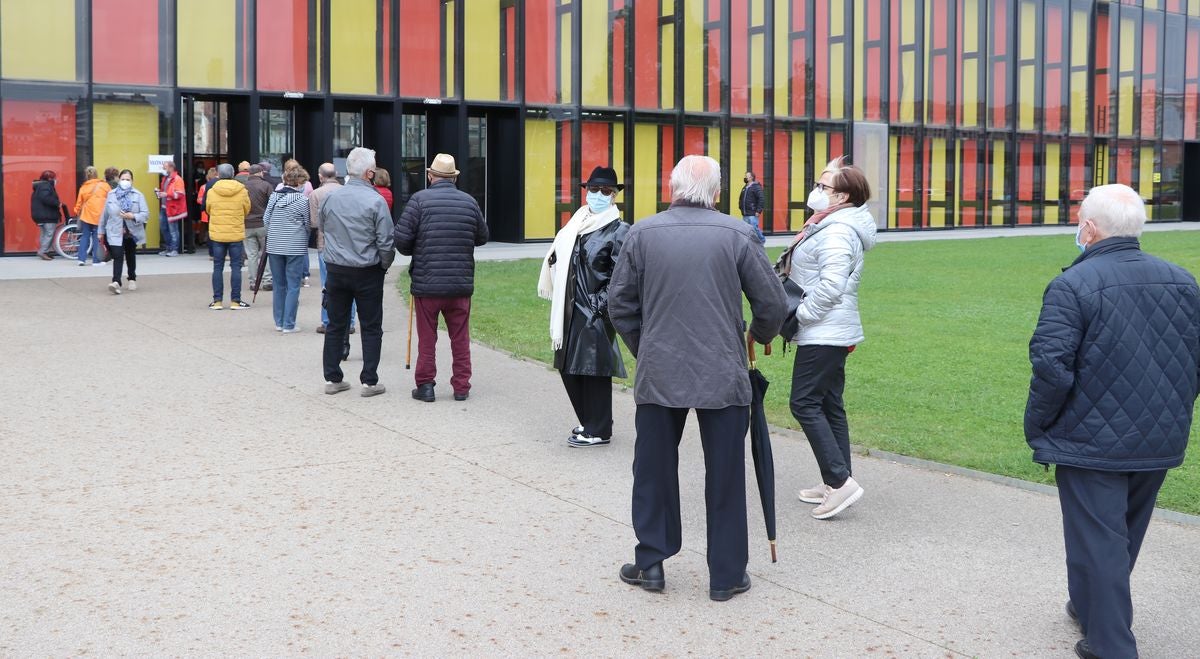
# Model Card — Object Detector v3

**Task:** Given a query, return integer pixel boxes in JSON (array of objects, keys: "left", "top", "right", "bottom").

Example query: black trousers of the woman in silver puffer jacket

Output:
[{"left": 791, "top": 346, "right": 851, "bottom": 489}]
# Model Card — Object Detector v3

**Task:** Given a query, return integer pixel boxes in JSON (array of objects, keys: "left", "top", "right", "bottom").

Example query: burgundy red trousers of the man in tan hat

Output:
[{"left": 413, "top": 296, "right": 470, "bottom": 394}]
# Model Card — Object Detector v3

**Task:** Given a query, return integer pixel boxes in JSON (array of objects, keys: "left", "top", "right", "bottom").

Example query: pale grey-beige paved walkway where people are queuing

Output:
[{"left": 0, "top": 232, "right": 1200, "bottom": 658}]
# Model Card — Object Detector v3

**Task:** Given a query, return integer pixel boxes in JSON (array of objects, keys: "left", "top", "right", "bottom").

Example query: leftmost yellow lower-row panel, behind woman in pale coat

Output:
[{"left": 91, "top": 103, "right": 160, "bottom": 247}]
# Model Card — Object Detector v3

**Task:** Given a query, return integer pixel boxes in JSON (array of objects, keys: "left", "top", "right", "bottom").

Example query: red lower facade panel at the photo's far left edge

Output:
[{"left": 0, "top": 101, "right": 78, "bottom": 253}]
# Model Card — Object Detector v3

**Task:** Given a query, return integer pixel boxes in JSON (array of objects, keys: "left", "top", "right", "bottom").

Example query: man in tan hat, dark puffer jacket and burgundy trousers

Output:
[{"left": 395, "top": 154, "right": 487, "bottom": 402}]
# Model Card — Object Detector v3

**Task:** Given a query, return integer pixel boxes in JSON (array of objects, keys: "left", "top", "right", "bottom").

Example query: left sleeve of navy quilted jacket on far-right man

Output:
[{"left": 1025, "top": 277, "right": 1084, "bottom": 439}]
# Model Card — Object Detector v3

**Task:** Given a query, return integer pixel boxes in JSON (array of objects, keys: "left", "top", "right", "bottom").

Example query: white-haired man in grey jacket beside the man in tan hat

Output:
[{"left": 318, "top": 146, "right": 396, "bottom": 396}]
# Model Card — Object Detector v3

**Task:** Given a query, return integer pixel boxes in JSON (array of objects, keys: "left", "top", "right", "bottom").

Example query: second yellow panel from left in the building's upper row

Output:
[{"left": 175, "top": 0, "right": 236, "bottom": 89}]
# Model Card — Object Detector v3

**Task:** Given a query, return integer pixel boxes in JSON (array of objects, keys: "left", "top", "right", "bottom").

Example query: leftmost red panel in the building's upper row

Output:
[{"left": 93, "top": 0, "right": 160, "bottom": 85}]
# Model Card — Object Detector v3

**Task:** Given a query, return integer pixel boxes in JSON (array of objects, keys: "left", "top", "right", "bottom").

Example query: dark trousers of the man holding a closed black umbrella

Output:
[{"left": 632, "top": 405, "right": 750, "bottom": 589}]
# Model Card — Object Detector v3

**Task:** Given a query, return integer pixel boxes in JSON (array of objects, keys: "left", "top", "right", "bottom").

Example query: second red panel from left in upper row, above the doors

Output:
[{"left": 254, "top": 0, "right": 308, "bottom": 91}]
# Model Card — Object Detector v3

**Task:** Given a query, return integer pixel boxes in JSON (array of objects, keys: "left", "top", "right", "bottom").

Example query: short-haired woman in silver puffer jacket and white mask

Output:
[{"left": 788, "top": 157, "right": 875, "bottom": 520}]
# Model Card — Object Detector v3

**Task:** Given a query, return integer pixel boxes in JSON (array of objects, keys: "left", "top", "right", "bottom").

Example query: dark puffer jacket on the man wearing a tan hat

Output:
[{"left": 395, "top": 180, "right": 487, "bottom": 298}]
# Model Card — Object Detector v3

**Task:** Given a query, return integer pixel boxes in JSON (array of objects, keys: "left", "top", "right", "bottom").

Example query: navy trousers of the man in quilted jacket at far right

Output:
[{"left": 1055, "top": 465, "right": 1166, "bottom": 659}]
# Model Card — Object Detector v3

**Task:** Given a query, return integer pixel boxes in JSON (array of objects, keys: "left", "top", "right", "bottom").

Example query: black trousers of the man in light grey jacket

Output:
[{"left": 322, "top": 263, "right": 384, "bottom": 384}]
